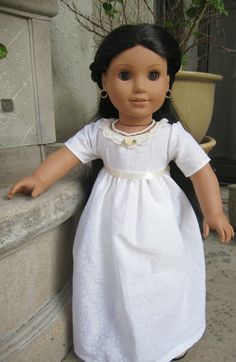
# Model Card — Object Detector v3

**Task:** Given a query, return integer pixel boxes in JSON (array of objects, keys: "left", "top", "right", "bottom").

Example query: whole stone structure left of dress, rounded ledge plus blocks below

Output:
[{"left": 0, "top": 178, "right": 84, "bottom": 362}]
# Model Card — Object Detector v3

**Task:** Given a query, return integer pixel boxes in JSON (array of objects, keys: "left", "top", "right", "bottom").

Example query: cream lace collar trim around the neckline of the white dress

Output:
[{"left": 101, "top": 118, "right": 168, "bottom": 148}]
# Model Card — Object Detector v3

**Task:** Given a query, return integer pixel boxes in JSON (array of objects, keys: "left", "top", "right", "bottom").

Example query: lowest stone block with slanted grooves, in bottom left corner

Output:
[{"left": 0, "top": 281, "right": 72, "bottom": 362}]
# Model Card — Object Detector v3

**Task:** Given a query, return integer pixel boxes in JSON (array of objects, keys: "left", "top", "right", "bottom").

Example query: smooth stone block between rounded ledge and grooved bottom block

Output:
[{"left": 0, "top": 219, "right": 77, "bottom": 338}]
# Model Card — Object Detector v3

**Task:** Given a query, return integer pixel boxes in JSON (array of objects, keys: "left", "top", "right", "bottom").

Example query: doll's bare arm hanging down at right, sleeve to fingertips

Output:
[{"left": 190, "top": 164, "right": 234, "bottom": 243}]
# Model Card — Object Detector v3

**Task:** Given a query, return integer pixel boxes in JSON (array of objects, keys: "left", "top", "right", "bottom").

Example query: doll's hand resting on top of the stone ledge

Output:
[{"left": 7, "top": 176, "right": 46, "bottom": 199}]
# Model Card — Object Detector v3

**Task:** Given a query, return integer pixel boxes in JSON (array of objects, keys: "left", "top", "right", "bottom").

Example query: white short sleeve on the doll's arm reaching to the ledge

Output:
[{"left": 65, "top": 121, "right": 100, "bottom": 163}]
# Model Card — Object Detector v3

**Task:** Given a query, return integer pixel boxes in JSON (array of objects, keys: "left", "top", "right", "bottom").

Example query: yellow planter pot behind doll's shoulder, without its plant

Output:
[{"left": 172, "top": 71, "right": 223, "bottom": 143}]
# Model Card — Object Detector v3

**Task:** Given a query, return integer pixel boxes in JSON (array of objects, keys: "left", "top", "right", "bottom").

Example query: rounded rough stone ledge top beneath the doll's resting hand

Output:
[{"left": 0, "top": 177, "right": 85, "bottom": 255}]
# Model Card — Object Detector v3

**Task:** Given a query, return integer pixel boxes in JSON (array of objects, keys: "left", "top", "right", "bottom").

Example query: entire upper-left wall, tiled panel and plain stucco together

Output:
[{"left": 0, "top": 0, "right": 97, "bottom": 188}]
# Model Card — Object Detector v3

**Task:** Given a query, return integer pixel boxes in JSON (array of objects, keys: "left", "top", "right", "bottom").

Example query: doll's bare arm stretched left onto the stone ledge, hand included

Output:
[{"left": 8, "top": 146, "right": 80, "bottom": 199}]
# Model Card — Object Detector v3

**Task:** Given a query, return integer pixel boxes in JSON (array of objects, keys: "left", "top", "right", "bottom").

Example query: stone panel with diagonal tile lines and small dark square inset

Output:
[{"left": 0, "top": 3, "right": 56, "bottom": 148}]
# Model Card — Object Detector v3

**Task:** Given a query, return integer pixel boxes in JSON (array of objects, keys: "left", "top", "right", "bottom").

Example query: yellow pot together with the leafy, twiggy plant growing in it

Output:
[{"left": 164, "top": 0, "right": 231, "bottom": 146}]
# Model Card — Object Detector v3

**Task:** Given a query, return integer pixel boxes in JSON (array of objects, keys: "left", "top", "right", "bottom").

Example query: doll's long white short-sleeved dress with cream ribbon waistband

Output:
[{"left": 65, "top": 119, "right": 209, "bottom": 362}]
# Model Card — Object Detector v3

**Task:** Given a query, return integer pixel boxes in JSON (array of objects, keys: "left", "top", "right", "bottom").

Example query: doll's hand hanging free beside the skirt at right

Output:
[{"left": 203, "top": 213, "right": 234, "bottom": 244}]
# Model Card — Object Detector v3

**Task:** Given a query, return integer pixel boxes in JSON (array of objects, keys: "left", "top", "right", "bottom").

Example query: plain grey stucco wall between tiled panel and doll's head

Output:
[{"left": 50, "top": 0, "right": 97, "bottom": 142}]
